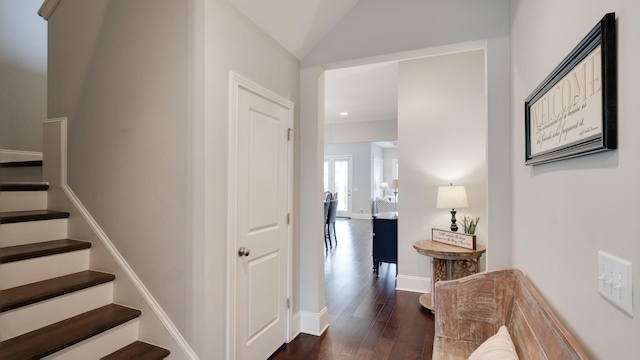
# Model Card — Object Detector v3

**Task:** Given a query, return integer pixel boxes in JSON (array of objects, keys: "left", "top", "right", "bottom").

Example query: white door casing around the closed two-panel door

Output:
[{"left": 226, "top": 71, "right": 294, "bottom": 360}]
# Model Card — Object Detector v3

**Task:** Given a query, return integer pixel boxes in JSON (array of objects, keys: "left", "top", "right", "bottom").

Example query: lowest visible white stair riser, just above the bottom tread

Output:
[{"left": 42, "top": 319, "right": 139, "bottom": 360}]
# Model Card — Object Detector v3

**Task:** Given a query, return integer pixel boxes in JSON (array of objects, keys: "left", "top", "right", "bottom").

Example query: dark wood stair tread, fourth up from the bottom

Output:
[{"left": 0, "top": 239, "right": 91, "bottom": 264}]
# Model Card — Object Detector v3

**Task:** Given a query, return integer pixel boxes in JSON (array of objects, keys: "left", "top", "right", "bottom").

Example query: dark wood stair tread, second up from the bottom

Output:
[{"left": 0, "top": 304, "right": 141, "bottom": 360}]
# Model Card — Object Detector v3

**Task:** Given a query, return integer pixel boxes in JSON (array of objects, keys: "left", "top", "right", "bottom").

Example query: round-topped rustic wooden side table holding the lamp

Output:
[{"left": 413, "top": 240, "right": 487, "bottom": 310}]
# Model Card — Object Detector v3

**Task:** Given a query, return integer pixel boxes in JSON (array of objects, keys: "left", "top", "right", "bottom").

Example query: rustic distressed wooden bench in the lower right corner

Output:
[{"left": 433, "top": 269, "right": 588, "bottom": 360}]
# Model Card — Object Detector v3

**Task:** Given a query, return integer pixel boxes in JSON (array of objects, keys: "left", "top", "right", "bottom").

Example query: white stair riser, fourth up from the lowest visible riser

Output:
[{"left": 0, "top": 219, "right": 67, "bottom": 247}]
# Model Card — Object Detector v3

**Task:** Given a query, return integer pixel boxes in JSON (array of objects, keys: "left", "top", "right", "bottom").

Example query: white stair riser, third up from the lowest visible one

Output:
[{"left": 0, "top": 249, "right": 90, "bottom": 290}]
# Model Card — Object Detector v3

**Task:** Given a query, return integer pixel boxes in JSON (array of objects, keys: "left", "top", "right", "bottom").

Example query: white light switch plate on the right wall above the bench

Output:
[{"left": 598, "top": 250, "right": 633, "bottom": 316}]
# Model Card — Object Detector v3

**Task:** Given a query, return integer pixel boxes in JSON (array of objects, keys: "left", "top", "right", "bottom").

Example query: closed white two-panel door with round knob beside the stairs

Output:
[{"left": 234, "top": 79, "right": 292, "bottom": 360}]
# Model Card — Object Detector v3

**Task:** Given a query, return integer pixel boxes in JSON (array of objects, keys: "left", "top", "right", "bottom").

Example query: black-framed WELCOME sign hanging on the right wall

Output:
[{"left": 524, "top": 13, "right": 618, "bottom": 165}]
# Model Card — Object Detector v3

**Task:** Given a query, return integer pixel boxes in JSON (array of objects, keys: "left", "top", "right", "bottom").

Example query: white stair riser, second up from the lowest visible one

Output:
[{"left": 0, "top": 282, "right": 113, "bottom": 341}]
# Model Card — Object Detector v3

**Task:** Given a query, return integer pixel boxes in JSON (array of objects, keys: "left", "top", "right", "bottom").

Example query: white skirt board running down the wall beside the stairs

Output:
[{"left": 43, "top": 118, "right": 199, "bottom": 360}]
